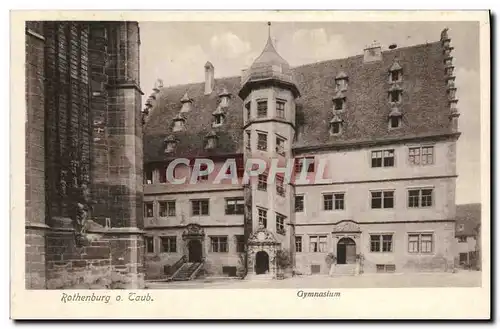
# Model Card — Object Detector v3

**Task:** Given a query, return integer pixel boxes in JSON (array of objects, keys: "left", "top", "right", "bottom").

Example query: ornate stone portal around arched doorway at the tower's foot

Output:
[{"left": 247, "top": 226, "right": 280, "bottom": 277}]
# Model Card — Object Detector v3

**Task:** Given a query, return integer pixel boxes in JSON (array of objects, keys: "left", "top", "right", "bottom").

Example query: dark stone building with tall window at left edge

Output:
[{"left": 25, "top": 21, "right": 144, "bottom": 289}]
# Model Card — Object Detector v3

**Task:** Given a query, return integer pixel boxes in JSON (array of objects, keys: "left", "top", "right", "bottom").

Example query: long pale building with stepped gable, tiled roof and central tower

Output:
[{"left": 143, "top": 25, "right": 460, "bottom": 278}]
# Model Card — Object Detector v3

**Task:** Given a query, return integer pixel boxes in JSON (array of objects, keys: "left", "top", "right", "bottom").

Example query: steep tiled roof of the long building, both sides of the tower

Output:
[{"left": 144, "top": 42, "right": 458, "bottom": 162}]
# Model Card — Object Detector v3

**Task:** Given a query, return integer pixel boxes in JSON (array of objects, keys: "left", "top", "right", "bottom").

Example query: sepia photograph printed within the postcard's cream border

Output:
[{"left": 12, "top": 12, "right": 490, "bottom": 318}]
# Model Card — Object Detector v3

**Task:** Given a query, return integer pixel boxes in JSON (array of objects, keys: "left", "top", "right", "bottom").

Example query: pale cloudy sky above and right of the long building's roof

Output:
[{"left": 140, "top": 22, "right": 481, "bottom": 204}]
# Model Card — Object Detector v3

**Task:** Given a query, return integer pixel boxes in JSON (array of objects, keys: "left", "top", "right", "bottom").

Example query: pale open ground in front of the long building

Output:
[{"left": 147, "top": 271, "right": 481, "bottom": 289}]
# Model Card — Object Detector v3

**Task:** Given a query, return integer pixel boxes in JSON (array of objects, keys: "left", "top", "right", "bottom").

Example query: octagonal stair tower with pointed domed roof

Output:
[{"left": 239, "top": 23, "right": 300, "bottom": 276}]
